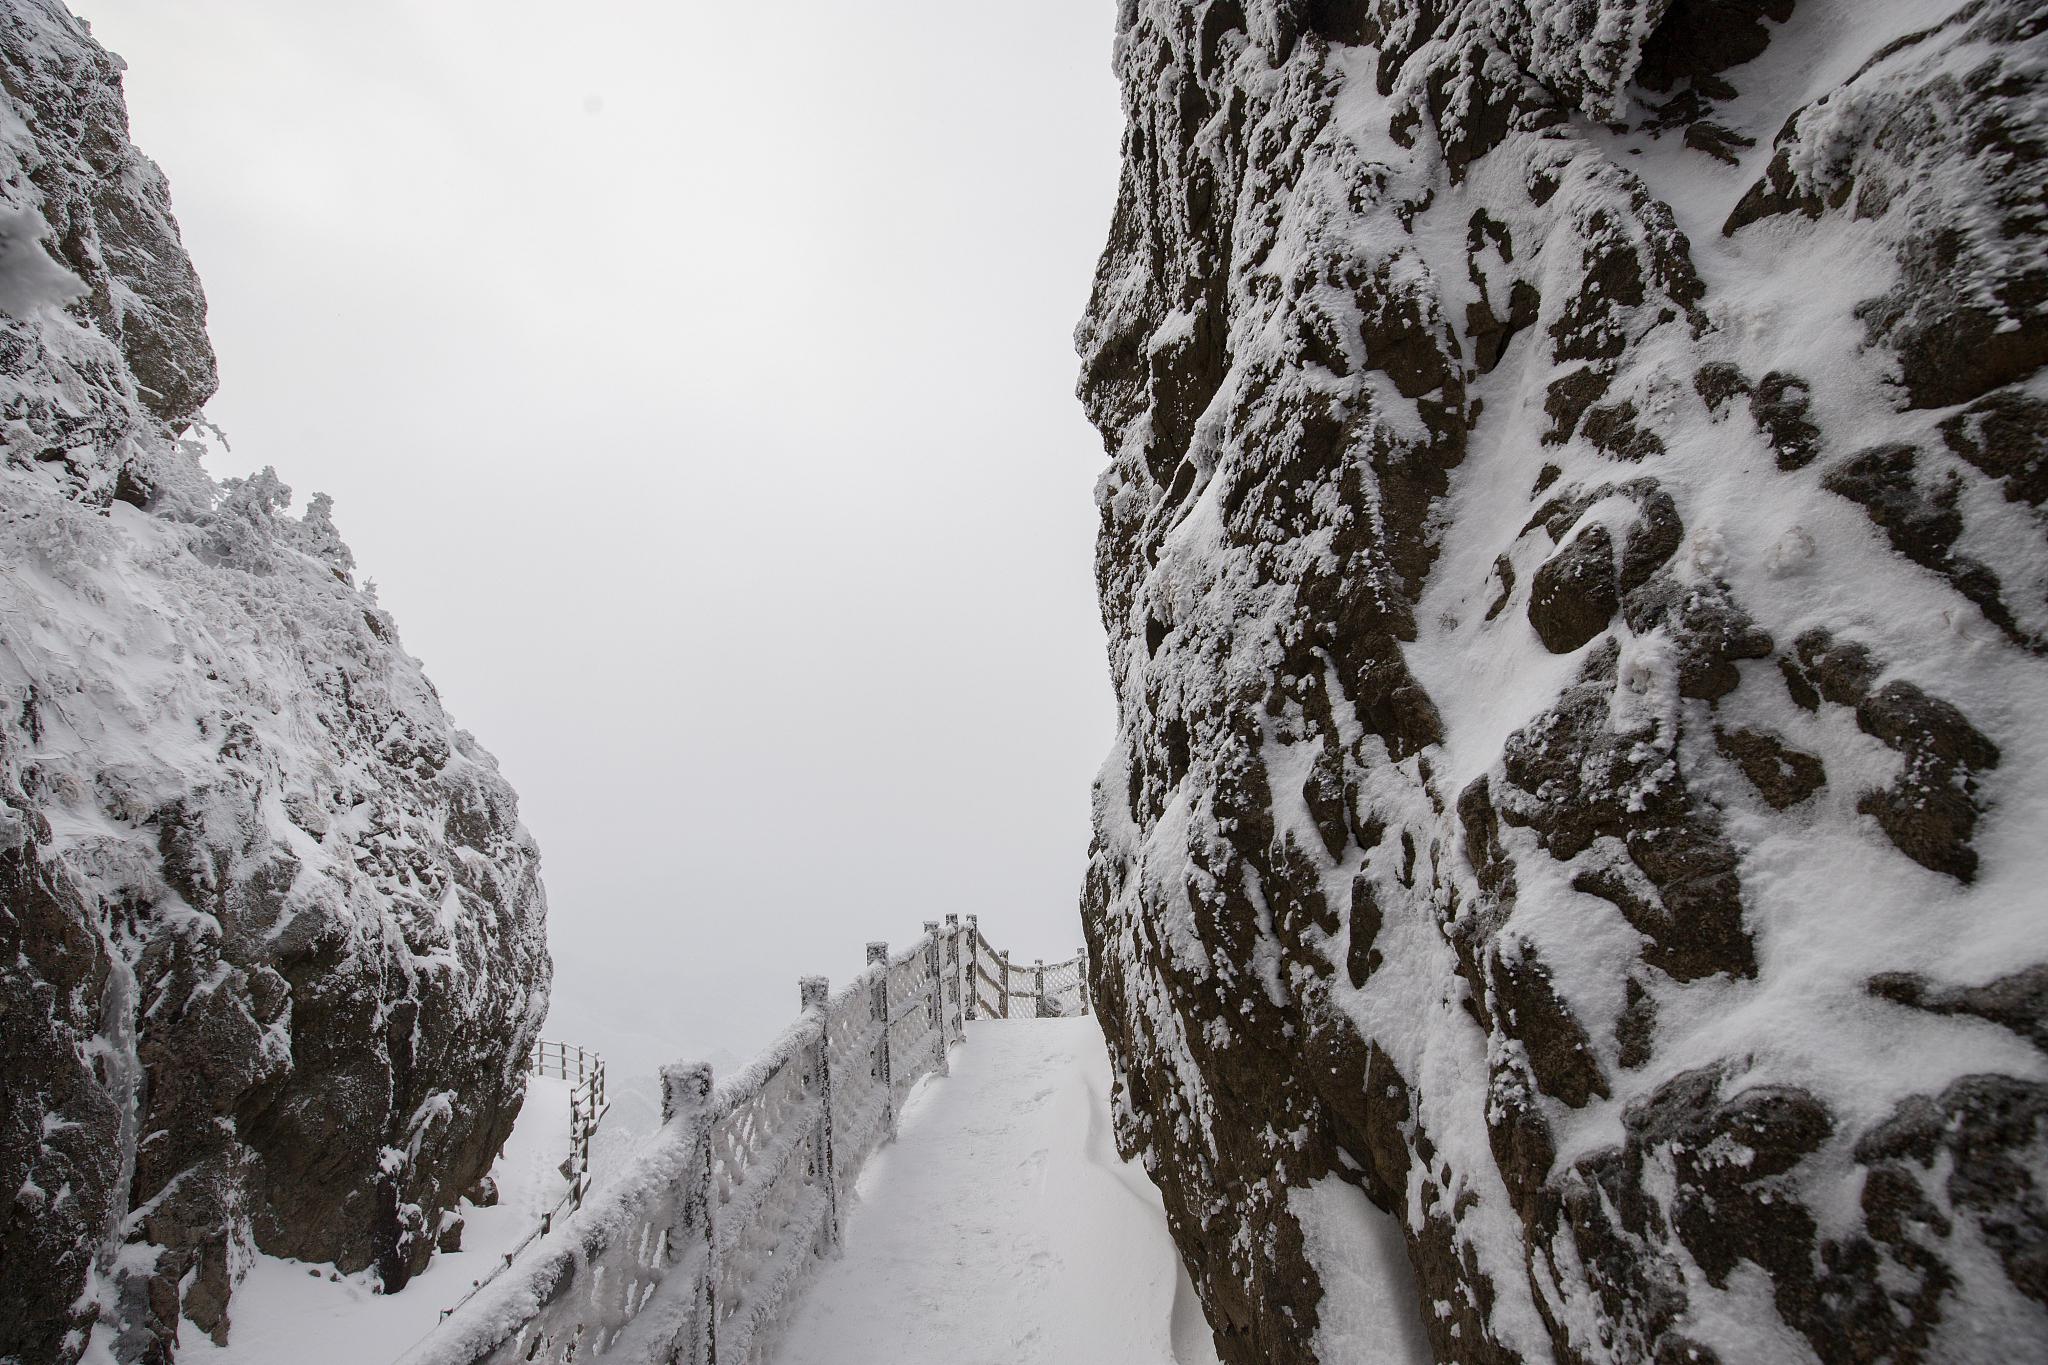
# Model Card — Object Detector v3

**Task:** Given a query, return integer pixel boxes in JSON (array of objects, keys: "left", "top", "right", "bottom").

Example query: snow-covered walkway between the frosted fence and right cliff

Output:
[{"left": 776, "top": 1017, "right": 1217, "bottom": 1365}]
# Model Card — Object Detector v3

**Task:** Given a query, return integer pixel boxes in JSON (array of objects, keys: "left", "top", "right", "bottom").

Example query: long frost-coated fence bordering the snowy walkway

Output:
[{"left": 389, "top": 915, "right": 1087, "bottom": 1365}]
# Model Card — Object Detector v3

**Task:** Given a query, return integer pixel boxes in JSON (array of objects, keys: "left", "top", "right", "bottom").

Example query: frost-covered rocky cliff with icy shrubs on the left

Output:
[{"left": 0, "top": 0, "right": 549, "bottom": 1363}]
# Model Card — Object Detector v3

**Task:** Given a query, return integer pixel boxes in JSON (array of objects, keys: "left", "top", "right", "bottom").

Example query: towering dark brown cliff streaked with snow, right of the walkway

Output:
[{"left": 1077, "top": 0, "right": 2048, "bottom": 1365}]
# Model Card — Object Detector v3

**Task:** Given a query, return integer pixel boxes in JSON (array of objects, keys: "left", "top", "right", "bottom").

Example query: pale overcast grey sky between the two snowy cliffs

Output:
[{"left": 74, "top": 0, "right": 1120, "bottom": 1096}]
